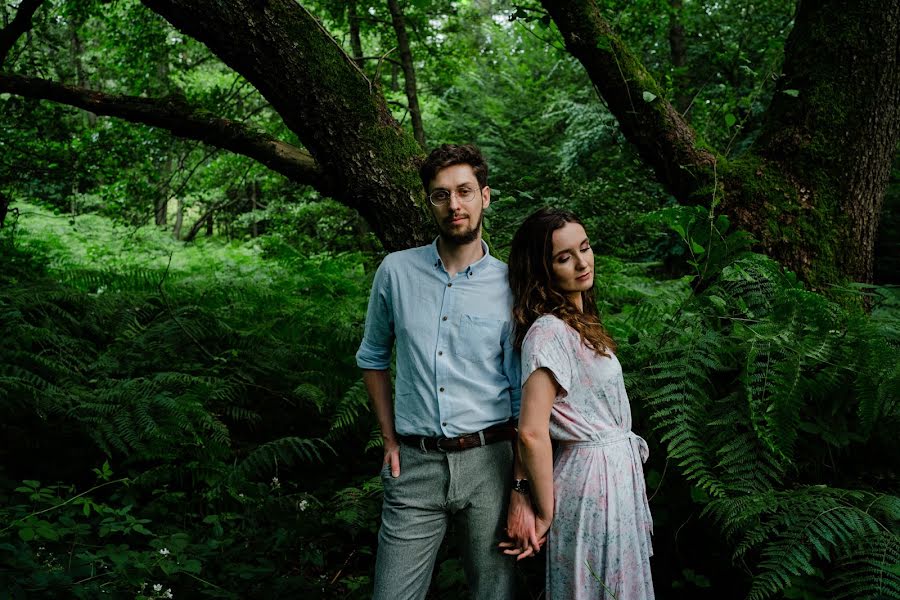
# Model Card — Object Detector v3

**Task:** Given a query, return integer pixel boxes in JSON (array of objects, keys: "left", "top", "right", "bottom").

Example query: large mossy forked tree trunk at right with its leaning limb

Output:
[{"left": 543, "top": 0, "right": 900, "bottom": 288}]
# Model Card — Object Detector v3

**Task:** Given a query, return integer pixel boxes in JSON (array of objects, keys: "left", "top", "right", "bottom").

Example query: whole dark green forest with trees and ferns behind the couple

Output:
[{"left": 0, "top": 0, "right": 900, "bottom": 599}]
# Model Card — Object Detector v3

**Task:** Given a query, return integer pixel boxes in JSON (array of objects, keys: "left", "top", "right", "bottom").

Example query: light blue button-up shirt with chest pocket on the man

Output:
[{"left": 356, "top": 240, "right": 521, "bottom": 437}]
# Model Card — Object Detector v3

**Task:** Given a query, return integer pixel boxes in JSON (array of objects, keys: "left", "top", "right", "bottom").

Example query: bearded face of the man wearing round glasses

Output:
[{"left": 429, "top": 164, "right": 491, "bottom": 245}]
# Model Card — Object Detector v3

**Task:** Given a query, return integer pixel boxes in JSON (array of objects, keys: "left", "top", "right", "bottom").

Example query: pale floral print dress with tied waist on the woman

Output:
[{"left": 522, "top": 315, "right": 653, "bottom": 600}]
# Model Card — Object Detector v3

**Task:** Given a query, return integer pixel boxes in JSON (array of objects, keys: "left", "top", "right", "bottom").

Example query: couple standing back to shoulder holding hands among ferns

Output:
[{"left": 356, "top": 145, "right": 653, "bottom": 600}]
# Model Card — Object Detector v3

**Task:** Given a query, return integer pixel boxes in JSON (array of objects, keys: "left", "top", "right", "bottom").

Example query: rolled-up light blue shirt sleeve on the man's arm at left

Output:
[{"left": 356, "top": 256, "right": 394, "bottom": 371}]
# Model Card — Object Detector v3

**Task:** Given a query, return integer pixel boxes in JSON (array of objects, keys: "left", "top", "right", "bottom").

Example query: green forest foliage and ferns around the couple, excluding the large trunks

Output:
[{"left": 0, "top": 0, "right": 900, "bottom": 600}]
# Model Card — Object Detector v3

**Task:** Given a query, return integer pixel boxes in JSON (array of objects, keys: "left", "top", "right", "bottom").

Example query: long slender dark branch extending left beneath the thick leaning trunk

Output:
[{"left": 0, "top": 74, "right": 331, "bottom": 195}]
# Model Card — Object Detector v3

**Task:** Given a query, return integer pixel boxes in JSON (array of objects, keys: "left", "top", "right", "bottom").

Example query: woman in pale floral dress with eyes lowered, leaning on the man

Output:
[{"left": 503, "top": 208, "right": 653, "bottom": 600}]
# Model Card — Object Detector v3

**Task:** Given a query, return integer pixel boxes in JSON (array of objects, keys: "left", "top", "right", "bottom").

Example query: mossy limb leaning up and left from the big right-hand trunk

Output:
[{"left": 542, "top": 0, "right": 716, "bottom": 202}]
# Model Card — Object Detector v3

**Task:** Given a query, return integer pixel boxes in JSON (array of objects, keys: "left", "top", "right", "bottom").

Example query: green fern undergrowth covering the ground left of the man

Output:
[{"left": 0, "top": 203, "right": 379, "bottom": 598}]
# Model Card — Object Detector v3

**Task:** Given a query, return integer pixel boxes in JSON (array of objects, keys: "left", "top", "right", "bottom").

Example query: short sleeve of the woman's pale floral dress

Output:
[{"left": 522, "top": 315, "right": 574, "bottom": 396}]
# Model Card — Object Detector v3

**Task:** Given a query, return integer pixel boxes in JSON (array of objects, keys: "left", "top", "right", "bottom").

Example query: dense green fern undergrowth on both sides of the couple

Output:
[{"left": 0, "top": 207, "right": 900, "bottom": 599}]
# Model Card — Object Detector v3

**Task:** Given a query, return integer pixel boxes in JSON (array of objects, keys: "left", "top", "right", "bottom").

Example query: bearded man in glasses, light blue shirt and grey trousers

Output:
[{"left": 356, "top": 145, "right": 530, "bottom": 600}]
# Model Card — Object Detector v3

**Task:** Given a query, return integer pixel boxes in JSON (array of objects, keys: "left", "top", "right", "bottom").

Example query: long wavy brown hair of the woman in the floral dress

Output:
[{"left": 509, "top": 208, "right": 616, "bottom": 356}]
